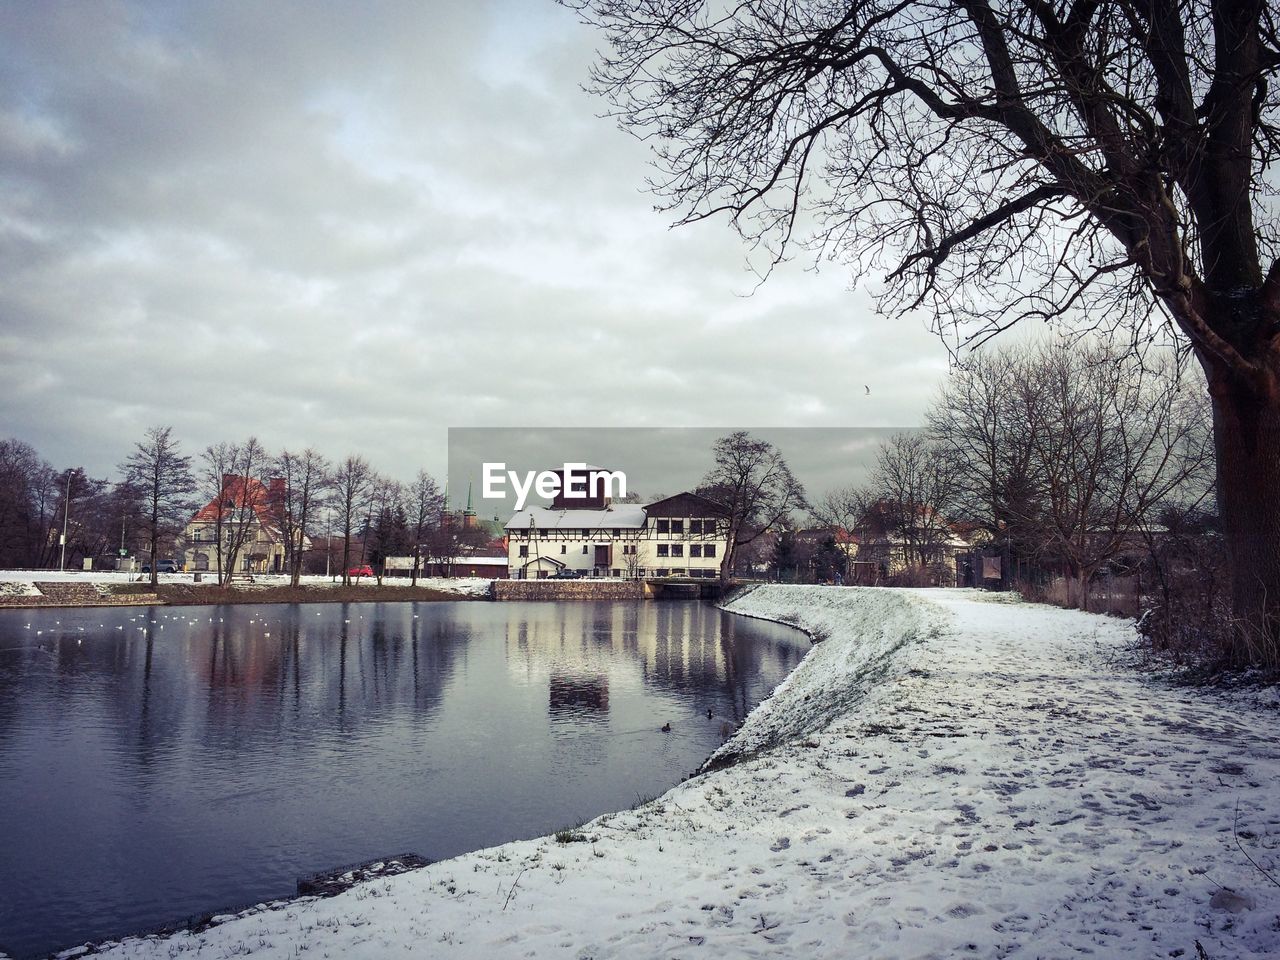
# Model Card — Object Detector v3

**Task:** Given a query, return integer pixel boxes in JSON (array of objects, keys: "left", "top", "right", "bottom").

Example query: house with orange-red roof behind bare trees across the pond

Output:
[{"left": 183, "top": 474, "right": 284, "bottom": 573}]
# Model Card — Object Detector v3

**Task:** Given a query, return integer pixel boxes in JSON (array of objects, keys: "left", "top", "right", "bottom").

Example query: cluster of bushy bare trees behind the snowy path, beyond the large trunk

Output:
[{"left": 815, "top": 344, "right": 1213, "bottom": 608}]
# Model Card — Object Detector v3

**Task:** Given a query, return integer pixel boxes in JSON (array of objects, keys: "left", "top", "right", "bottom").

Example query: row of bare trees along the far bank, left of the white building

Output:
[{"left": 0, "top": 426, "right": 485, "bottom": 586}]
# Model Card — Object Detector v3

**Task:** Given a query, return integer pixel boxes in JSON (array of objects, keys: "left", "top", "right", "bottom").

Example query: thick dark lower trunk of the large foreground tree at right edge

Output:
[{"left": 1208, "top": 366, "right": 1280, "bottom": 668}]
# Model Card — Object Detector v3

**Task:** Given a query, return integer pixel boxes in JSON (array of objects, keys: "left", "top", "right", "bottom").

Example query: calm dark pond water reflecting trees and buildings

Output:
[{"left": 0, "top": 603, "right": 809, "bottom": 956}]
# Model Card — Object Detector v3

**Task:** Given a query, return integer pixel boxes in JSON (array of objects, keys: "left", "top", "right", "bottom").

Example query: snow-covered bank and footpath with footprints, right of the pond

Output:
[{"left": 77, "top": 585, "right": 1280, "bottom": 960}]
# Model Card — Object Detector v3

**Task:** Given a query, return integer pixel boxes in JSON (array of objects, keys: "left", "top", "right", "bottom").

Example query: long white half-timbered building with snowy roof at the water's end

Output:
[{"left": 506, "top": 473, "right": 727, "bottom": 580}]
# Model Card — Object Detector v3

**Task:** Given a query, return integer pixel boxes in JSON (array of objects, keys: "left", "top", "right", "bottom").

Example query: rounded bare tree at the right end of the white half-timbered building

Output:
[{"left": 698, "top": 430, "right": 808, "bottom": 584}]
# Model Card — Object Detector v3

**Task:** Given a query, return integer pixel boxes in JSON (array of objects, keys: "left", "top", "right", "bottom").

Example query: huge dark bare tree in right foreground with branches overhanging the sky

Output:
[{"left": 571, "top": 0, "right": 1280, "bottom": 662}]
